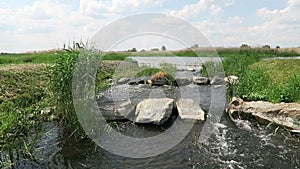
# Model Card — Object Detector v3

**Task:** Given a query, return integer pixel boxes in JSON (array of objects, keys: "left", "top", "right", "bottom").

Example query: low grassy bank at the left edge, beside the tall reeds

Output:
[{"left": 0, "top": 64, "right": 53, "bottom": 168}]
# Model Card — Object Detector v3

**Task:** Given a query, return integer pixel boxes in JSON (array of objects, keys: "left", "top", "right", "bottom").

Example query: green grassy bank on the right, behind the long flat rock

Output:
[{"left": 224, "top": 57, "right": 300, "bottom": 103}]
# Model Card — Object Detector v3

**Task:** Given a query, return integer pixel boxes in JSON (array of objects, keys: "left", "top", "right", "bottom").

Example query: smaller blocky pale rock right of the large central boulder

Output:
[{"left": 176, "top": 99, "right": 205, "bottom": 121}]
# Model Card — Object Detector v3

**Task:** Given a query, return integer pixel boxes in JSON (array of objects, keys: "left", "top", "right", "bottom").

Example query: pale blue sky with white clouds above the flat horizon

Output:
[{"left": 0, "top": 0, "right": 300, "bottom": 52}]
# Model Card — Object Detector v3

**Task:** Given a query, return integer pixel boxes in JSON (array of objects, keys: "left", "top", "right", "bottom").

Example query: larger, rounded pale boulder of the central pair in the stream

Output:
[{"left": 135, "top": 98, "right": 174, "bottom": 125}]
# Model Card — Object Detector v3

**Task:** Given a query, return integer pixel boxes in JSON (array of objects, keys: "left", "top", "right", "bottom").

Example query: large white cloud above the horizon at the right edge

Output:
[{"left": 191, "top": 0, "right": 300, "bottom": 47}]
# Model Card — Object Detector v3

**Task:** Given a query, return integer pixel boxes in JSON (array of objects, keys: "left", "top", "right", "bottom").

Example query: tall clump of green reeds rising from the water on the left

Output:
[{"left": 49, "top": 43, "right": 112, "bottom": 137}]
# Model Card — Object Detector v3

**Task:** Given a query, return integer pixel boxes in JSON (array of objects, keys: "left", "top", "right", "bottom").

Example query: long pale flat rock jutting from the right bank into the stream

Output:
[{"left": 227, "top": 98, "right": 300, "bottom": 132}]
